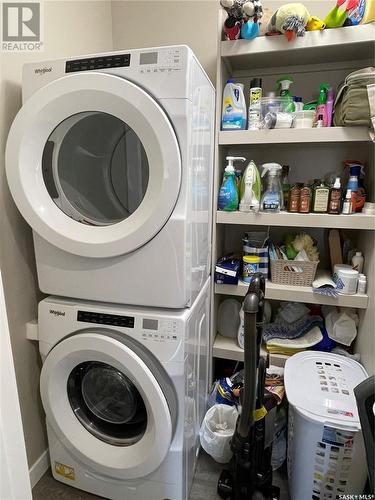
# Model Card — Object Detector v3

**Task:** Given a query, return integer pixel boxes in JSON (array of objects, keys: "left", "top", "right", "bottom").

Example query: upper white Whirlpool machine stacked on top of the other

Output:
[{"left": 6, "top": 46, "right": 214, "bottom": 308}]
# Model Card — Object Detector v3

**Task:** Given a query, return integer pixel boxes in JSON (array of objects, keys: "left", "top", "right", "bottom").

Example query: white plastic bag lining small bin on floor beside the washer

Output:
[{"left": 199, "top": 405, "right": 238, "bottom": 464}]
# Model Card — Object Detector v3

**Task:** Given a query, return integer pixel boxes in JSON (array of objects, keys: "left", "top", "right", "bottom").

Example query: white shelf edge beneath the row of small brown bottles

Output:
[{"left": 216, "top": 211, "right": 375, "bottom": 231}]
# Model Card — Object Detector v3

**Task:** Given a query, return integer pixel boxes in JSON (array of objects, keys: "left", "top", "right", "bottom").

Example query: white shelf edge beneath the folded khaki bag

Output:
[{"left": 219, "top": 127, "right": 370, "bottom": 146}]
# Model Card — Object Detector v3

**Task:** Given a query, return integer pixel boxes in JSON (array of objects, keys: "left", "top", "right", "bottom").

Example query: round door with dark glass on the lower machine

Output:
[{"left": 40, "top": 330, "right": 177, "bottom": 479}]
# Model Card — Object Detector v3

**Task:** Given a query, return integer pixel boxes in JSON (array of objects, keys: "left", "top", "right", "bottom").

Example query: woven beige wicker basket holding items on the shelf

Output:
[{"left": 270, "top": 259, "right": 319, "bottom": 286}]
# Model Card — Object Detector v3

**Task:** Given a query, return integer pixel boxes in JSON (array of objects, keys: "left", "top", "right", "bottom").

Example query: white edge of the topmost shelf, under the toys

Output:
[{"left": 220, "top": 23, "right": 375, "bottom": 58}]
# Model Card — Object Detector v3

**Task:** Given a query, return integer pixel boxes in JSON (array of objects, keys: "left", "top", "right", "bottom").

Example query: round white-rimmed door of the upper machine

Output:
[{"left": 6, "top": 72, "right": 181, "bottom": 257}]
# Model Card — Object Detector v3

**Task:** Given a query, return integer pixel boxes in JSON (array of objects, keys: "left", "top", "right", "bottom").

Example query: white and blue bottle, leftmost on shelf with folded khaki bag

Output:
[{"left": 221, "top": 80, "right": 246, "bottom": 130}]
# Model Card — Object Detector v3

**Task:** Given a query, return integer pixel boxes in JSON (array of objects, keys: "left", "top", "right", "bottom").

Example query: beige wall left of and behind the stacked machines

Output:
[{"left": 0, "top": 0, "right": 112, "bottom": 465}]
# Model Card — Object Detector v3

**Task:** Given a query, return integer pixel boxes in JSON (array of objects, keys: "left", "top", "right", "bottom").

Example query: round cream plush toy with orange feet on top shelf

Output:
[{"left": 267, "top": 3, "right": 311, "bottom": 41}]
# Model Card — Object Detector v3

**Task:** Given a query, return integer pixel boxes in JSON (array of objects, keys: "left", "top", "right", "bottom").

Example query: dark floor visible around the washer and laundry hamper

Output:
[{"left": 33, "top": 451, "right": 289, "bottom": 500}]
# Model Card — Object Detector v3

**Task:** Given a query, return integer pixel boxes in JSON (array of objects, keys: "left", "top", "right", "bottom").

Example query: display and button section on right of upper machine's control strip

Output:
[{"left": 139, "top": 47, "right": 182, "bottom": 73}]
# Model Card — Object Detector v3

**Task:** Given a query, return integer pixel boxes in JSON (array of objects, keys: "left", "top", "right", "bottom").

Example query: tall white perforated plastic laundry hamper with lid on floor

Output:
[{"left": 284, "top": 351, "right": 367, "bottom": 500}]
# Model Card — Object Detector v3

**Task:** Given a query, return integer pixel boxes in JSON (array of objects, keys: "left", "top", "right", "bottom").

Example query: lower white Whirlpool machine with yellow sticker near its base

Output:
[{"left": 38, "top": 281, "right": 210, "bottom": 500}]
